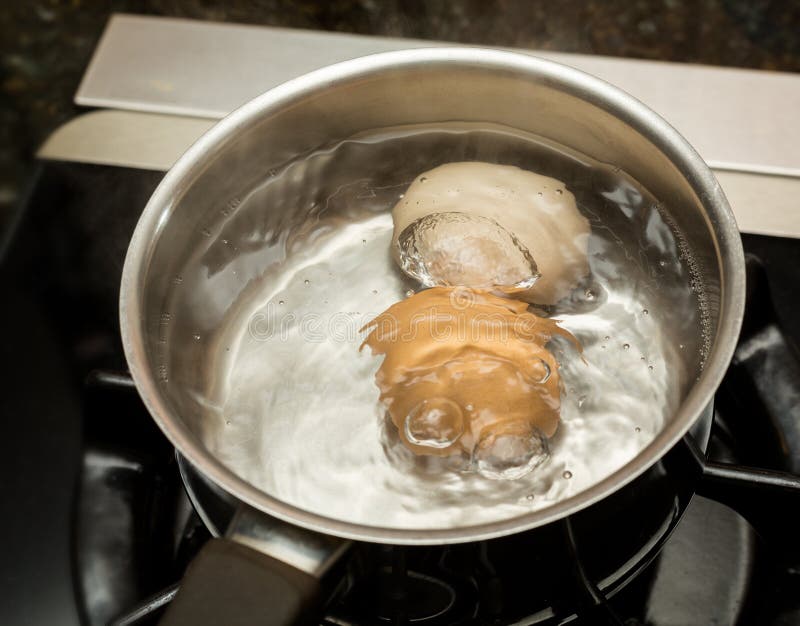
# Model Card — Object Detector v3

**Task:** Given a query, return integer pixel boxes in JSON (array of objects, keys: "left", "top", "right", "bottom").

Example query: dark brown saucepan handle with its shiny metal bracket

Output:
[{"left": 160, "top": 506, "right": 349, "bottom": 626}]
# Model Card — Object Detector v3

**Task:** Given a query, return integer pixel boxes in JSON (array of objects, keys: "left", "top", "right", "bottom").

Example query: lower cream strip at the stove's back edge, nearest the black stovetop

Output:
[{"left": 37, "top": 110, "right": 800, "bottom": 238}]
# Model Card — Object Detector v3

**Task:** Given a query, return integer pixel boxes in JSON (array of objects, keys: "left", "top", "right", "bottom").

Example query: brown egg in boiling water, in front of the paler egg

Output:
[{"left": 362, "top": 287, "right": 579, "bottom": 456}]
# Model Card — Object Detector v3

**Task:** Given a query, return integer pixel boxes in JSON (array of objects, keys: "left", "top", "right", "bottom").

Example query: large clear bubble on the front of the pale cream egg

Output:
[{"left": 397, "top": 211, "right": 539, "bottom": 289}]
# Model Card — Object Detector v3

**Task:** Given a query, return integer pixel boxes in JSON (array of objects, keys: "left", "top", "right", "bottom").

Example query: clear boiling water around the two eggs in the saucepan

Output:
[{"left": 174, "top": 126, "right": 707, "bottom": 528}]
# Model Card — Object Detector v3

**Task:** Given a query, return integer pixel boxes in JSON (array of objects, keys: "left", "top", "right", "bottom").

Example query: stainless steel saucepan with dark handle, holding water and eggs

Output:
[{"left": 120, "top": 48, "right": 745, "bottom": 624}]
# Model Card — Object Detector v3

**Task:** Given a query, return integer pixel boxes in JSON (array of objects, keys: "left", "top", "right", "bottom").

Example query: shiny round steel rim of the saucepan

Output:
[{"left": 120, "top": 48, "right": 745, "bottom": 545}]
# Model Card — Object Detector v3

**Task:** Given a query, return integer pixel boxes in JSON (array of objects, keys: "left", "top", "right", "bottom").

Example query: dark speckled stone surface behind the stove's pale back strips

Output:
[{"left": 0, "top": 0, "right": 800, "bottom": 230}]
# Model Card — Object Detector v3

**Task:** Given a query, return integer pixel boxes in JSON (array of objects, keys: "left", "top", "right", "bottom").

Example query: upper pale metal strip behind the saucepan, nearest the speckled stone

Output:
[{"left": 75, "top": 14, "right": 800, "bottom": 175}]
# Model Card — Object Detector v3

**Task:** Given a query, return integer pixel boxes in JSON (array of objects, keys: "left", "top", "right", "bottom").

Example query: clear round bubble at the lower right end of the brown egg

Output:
[{"left": 473, "top": 424, "right": 548, "bottom": 480}]
